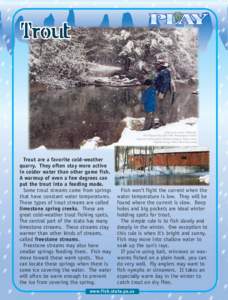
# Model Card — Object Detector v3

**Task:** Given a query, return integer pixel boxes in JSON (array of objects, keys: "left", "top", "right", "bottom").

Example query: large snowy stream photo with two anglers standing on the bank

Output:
[{"left": 29, "top": 27, "right": 198, "bottom": 149}]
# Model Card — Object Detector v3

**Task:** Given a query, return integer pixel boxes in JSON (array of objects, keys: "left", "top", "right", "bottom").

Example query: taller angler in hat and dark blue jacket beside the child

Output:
[{"left": 155, "top": 60, "right": 175, "bottom": 125}]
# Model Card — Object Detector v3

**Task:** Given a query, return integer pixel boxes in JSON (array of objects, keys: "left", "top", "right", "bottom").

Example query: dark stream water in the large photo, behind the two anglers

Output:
[{"left": 30, "top": 86, "right": 197, "bottom": 149}]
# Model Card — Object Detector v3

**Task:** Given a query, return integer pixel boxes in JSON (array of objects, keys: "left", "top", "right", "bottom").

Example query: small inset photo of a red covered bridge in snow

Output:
[{"left": 115, "top": 146, "right": 209, "bottom": 185}]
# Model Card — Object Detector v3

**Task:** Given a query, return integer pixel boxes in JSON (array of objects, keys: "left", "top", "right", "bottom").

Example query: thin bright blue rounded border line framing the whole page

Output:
[{"left": 11, "top": 7, "right": 219, "bottom": 296}]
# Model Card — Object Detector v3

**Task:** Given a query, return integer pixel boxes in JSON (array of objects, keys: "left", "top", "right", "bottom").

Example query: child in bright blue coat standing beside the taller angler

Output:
[{"left": 141, "top": 79, "right": 156, "bottom": 130}]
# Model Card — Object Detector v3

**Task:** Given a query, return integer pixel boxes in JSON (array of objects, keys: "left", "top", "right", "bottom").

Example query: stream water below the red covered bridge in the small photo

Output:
[{"left": 115, "top": 175, "right": 207, "bottom": 185}]
